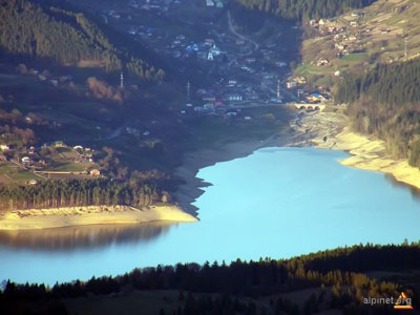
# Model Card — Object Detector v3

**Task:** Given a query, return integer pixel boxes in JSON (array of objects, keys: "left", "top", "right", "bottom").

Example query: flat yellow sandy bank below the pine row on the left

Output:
[{"left": 0, "top": 205, "right": 197, "bottom": 230}]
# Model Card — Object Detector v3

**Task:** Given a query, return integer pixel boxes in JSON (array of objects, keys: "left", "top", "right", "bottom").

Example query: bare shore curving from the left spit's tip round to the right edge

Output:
[{"left": 175, "top": 107, "right": 420, "bottom": 216}]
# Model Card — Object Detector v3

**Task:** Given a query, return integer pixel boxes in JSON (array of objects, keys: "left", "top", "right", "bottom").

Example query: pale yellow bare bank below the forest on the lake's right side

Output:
[{"left": 291, "top": 108, "right": 420, "bottom": 190}]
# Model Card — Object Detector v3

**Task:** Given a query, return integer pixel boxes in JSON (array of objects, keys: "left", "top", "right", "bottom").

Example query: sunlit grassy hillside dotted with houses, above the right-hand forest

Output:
[{"left": 297, "top": 0, "right": 420, "bottom": 85}]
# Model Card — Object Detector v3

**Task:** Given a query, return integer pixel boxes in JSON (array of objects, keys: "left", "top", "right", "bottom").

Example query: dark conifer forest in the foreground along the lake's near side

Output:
[{"left": 0, "top": 243, "right": 420, "bottom": 315}]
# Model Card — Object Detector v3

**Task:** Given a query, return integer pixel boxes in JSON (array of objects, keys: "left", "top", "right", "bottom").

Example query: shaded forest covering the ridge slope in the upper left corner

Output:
[{"left": 0, "top": 0, "right": 163, "bottom": 79}]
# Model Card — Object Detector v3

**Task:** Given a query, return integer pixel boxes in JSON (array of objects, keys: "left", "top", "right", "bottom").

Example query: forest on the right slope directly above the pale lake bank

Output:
[{"left": 336, "top": 59, "right": 420, "bottom": 167}]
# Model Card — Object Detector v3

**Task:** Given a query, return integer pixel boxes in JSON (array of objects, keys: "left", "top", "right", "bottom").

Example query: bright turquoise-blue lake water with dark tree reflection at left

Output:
[{"left": 0, "top": 148, "right": 420, "bottom": 284}]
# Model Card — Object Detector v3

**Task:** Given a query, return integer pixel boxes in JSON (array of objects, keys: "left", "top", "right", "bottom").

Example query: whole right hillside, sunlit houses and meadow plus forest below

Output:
[{"left": 295, "top": 0, "right": 420, "bottom": 167}]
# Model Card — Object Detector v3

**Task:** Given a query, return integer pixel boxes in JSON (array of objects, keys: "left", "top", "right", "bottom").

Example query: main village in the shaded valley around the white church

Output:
[{"left": 98, "top": 0, "right": 331, "bottom": 116}]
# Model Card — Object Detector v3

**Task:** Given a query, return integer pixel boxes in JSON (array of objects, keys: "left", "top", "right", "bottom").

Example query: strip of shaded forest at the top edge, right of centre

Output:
[{"left": 236, "top": 0, "right": 376, "bottom": 20}]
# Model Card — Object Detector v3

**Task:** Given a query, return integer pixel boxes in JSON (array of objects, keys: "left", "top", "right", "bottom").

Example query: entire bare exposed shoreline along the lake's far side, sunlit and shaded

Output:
[{"left": 0, "top": 107, "right": 420, "bottom": 231}]
